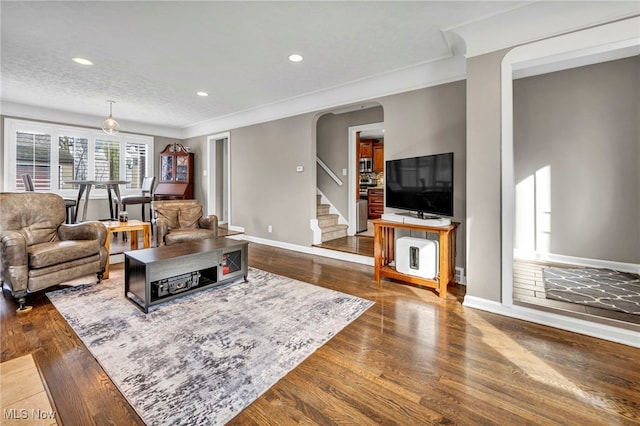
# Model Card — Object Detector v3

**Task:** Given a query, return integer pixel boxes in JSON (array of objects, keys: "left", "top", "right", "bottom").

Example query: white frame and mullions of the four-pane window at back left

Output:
[{"left": 2, "top": 118, "right": 155, "bottom": 199}]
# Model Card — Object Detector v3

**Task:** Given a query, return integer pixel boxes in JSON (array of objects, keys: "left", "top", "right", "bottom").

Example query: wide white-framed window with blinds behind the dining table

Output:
[{"left": 4, "top": 119, "right": 153, "bottom": 197}]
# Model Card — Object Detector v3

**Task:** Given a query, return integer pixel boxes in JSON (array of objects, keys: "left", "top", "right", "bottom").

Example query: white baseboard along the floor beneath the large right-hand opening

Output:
[{"left": 462, "top": 295, "right": 640, "bottom": 348}]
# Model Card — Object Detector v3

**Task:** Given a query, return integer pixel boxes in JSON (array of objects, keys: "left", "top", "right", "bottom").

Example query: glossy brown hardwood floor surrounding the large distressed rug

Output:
[{"left": 0, "top": 243, "right": 640, "bottom": 425}]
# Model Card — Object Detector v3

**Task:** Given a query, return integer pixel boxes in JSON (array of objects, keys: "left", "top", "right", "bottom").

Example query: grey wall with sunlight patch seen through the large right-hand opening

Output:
[{"left": 513, "top": 56, "right": 640, "bottom": 263}]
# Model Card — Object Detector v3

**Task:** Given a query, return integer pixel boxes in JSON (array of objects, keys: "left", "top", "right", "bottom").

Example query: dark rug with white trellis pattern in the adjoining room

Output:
[{"left": 542, "top": 268, "right": 640, "bottom": 314}]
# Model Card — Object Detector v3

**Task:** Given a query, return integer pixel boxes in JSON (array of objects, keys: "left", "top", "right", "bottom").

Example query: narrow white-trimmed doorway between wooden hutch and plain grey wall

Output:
[{"left": 205, "top": 132, "right": 231, "bottom": 225}]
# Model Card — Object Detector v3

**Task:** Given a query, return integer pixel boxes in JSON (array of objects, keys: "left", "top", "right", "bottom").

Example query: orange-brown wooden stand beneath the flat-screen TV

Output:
[{"left": 372, "top": 219, "right": 460, "bottom": 298}]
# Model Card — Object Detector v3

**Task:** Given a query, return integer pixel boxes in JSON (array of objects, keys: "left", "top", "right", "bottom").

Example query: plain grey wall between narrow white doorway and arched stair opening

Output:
[{"left": 225, "top": 114, "right": 316, "bottom": 247}]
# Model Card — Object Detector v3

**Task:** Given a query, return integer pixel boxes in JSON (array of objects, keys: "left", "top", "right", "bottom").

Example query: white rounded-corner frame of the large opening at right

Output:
[{"left": 500, "top": 21, "right": 638, "bottom": 345}]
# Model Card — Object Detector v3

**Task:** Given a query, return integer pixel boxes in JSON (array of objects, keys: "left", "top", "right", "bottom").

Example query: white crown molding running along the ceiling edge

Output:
[{"left": 5, "top": 1, "right": 640, "bottom": 139}]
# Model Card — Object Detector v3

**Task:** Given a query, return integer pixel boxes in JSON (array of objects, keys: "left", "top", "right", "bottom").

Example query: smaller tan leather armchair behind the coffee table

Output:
[{"left": 151, "top": 200, "right": 218, "bottom": 246}]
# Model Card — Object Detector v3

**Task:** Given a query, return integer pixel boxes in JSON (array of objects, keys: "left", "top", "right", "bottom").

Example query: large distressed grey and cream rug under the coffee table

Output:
[{"left": 47, "top": 268, "right": 373, "bottom": 426}]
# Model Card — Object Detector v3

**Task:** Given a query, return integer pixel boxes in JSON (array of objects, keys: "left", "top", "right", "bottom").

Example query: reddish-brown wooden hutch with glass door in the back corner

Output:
[{"left": 154, "top": 144, "right": 194, "bottom": 200}]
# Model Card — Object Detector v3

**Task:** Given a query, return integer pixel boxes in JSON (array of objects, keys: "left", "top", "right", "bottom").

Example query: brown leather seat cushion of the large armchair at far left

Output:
[{"left": 27, "top": 240, "right": 100, "bottom": 268}]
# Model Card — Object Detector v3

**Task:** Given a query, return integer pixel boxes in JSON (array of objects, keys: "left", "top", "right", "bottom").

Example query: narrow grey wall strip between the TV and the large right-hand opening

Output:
[{"left": 466, "top": 50, "right": 506, "bottom": 301}]
